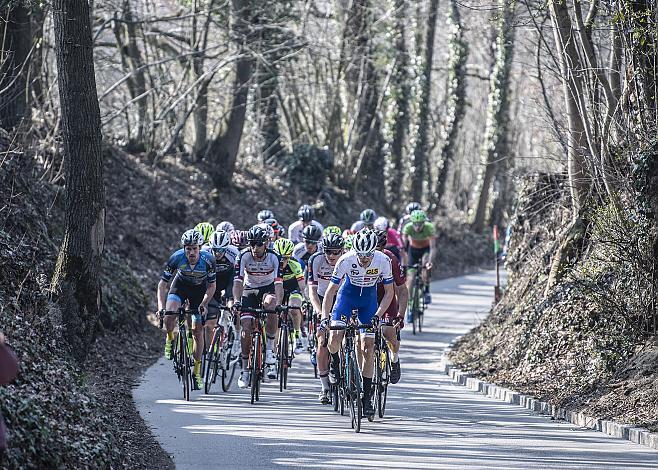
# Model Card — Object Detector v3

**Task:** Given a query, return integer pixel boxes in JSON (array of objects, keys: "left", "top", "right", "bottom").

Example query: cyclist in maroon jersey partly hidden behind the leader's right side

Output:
[{"left": 375, "top": 230, "right": 409, "bottom": 384}]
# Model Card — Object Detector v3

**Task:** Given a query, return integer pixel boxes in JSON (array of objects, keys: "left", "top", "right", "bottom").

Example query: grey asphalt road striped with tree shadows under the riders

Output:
[{"left": 134, "top": 272, "right": 658, "bottom": 469}]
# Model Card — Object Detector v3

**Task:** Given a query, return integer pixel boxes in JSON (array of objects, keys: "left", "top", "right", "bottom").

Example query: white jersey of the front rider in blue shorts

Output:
[{"left": 331, "top": 251, "right": 393, "bottom": 288}]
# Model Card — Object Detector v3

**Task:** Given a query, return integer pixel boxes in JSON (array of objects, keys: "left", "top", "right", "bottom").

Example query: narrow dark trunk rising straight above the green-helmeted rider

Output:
[{"left": 410, "top": 0, "right": 439, "bottom": 201}]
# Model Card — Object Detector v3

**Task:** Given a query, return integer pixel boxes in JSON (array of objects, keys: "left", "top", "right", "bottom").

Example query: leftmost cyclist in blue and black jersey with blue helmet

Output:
[{"left": 158, "top": 229, "right": 217, "bottom": 389}]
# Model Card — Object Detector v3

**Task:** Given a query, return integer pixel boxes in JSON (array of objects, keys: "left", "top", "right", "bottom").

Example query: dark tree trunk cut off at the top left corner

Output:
[{"left": 0, "top": 4, "right": 32, "bottom": 129}]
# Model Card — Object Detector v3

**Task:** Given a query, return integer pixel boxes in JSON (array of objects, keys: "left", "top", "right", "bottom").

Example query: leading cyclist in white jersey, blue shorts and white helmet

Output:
[{"left": 322, "top": 230, "right": 395, "bottom": 416}]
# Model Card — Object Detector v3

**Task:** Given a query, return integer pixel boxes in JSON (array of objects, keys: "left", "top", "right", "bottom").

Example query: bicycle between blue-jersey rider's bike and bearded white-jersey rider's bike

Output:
[{"left": 204, "top": 305, "right": 240, "bottom": 394}]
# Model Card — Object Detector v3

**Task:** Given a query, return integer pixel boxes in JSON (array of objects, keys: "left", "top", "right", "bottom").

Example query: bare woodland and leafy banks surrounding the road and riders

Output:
[{"left": 0, "top": 0, "right": 658, "bottom": 468}]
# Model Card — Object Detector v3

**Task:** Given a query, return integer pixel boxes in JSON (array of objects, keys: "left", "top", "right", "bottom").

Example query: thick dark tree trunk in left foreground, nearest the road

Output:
[{"left": 51, "top": 0, "right": 105, "bottom": 361}]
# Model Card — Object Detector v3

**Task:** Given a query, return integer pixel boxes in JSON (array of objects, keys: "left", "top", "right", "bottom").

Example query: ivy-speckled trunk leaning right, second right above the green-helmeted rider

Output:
[{"left": 432, "top": 0, "right": 468, "bottom": 210}]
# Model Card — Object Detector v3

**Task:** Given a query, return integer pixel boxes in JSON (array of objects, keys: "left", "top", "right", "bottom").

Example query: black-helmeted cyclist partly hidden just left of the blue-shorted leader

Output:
[{"left": 306, "top": 233, "right": 345, "bottom": 405}]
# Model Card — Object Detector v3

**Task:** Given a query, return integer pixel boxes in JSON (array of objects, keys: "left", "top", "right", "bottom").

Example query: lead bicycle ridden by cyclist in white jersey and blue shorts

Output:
[{"left": 329, "top": 310, "right": 372, "bottom": 432}]
